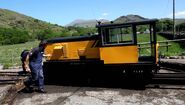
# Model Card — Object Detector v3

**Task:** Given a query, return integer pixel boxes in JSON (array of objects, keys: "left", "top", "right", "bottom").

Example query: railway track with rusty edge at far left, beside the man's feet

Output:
[{"left": 0, "top": 71, "right": 29, "bottom": 105}]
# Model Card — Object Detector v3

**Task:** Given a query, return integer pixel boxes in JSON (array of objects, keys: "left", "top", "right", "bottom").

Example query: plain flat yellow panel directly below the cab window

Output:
[{"left": 100, "top": 46, "right": 138, "bottom": 64}]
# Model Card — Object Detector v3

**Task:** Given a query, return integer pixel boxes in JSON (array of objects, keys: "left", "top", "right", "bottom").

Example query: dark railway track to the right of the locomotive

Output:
[{"left": 151, "top": 59, "right": 185, "bottom": 85}]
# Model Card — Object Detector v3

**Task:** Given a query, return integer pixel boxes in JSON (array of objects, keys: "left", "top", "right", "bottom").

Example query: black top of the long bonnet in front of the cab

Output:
[{"left": 47, "top": 35, "right": 98, "bottom": 43}]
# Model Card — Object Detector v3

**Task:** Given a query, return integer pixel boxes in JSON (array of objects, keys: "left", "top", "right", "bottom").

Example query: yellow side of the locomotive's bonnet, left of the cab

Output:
[{"left": 45, "top": 40, "right": 100, "bottom": 60}]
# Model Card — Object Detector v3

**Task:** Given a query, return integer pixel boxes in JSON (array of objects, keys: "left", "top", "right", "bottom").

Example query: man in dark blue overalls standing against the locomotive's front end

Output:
[{"left": 29, "top": 41, "right": 47, "bottom": 93}]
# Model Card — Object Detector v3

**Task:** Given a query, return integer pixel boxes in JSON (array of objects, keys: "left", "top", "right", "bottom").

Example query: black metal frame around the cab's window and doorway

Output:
[{"left": 96, "top": 19, "right": 158, "bottom": 62}]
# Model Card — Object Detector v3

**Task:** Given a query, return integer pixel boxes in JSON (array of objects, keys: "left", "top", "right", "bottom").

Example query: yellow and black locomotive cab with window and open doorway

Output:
[{"left": 97, "top": 20, "right": 158, "bottom": 64}]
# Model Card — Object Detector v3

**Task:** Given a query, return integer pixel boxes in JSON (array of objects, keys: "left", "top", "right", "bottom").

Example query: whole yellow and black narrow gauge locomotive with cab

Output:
[{"left": 44, "top": 19, "right": 158, "bottom": 82}]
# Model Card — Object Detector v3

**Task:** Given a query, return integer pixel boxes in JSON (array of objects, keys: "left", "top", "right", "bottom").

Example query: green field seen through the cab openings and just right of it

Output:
[{"left": 108, "top": 34, "right": 185, "bottom": 56}]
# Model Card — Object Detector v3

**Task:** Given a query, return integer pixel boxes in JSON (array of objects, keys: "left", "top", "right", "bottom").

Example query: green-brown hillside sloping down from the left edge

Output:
[{"left": 0, "top": 9, "right": 63, "bottom": 35}]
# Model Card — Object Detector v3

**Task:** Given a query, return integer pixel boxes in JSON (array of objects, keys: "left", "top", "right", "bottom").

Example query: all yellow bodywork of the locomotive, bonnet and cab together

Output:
[{"left": 45, "top": 40, "right": 159, "bottom": 64}]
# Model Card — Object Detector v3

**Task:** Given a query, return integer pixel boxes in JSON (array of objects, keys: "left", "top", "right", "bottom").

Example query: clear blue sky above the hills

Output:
[{"left": 0, "top": 0, "right": 185, "bottom": 26}]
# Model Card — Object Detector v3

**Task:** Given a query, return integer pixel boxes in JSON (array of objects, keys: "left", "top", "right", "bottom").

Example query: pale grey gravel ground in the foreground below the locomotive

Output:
[{"left": 13, "top": 85, "right": 185, "bottom": 105}]
